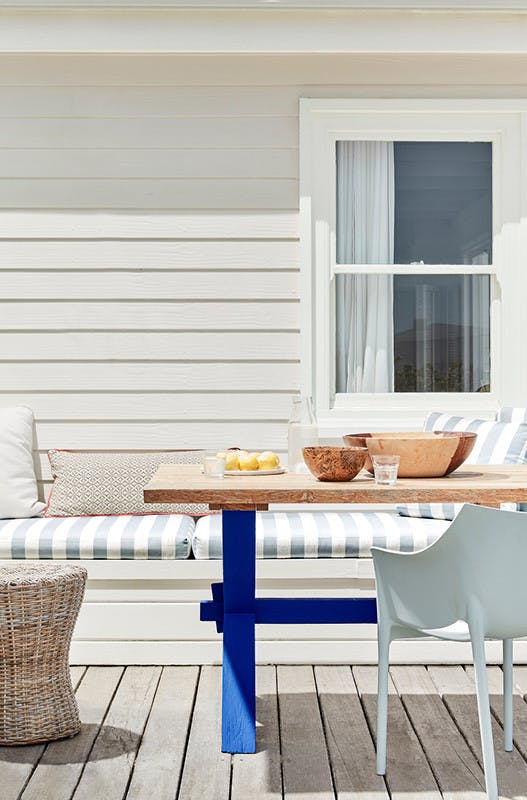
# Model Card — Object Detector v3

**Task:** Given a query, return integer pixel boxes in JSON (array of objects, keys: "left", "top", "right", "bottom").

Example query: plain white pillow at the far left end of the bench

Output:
[{"left": 0, "top": 406, "right": 44, "bottom": 519}]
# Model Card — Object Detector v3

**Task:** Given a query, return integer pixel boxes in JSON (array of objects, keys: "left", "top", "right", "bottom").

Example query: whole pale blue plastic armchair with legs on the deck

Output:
[{"left": 372, "top": 505, "right": 527, "bottom": 800}]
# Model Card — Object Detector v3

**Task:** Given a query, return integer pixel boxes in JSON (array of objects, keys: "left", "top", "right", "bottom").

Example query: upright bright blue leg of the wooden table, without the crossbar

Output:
[{"left": 221, "top": 511, "right": 256, "bottom": 753}]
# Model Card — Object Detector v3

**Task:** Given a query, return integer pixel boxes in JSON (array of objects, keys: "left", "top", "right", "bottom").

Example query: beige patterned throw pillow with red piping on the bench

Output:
[{"left": 44, "top": 450, "right": 209, "bottom": 517}]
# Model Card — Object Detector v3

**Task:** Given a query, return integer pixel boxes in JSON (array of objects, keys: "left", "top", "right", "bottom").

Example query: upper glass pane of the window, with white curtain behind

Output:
[{"left": 336, "top": 141, "right": 492, "bottom": 264}]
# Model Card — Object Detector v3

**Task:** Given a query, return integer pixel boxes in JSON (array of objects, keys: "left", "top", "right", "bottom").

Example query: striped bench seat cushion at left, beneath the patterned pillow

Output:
[{"left": 0, "top": 514, "right": 194, "bottom": 560}]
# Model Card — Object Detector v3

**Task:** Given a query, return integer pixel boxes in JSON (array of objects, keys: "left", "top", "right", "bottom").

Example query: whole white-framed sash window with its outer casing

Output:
[{"left": 300, "top": 100, "right": 527, "bottom": 427}]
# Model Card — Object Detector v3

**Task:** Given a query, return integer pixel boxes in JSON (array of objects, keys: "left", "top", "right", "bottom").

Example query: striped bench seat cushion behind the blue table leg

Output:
[{"left": 192, "top": 511, "right": 449, "bottom": 559}]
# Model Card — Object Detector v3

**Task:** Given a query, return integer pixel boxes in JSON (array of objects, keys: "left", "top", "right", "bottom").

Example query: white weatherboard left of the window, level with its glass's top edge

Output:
[{"left": 0, "top": 114, "right": 298, "bottom": 148}]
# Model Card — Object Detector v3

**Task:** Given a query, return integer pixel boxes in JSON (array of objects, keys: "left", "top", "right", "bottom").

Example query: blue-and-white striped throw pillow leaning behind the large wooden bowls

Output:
[{"left": 397, "top": 413, "right": 527, "bottom": 520}]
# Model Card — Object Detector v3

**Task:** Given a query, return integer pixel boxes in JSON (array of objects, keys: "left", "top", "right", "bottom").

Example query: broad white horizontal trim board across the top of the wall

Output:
[{"left": 0, "top": 4, "right": 527, "bottom": 56}]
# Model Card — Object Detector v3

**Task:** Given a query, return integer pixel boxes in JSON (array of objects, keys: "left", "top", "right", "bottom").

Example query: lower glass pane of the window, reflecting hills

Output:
[{"left": 335, "top": 274, "right": 490, "bottom": 393}]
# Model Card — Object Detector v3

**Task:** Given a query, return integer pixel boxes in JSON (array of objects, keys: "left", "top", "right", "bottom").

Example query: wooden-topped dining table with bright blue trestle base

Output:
[{"left": 144, "top": 465, "right": 527, "bottom": 753}]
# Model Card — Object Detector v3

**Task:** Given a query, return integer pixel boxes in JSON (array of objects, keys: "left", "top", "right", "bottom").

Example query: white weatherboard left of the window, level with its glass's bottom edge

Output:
[{"left": 0, "top": 362, "right": 299, "bottom": 390}]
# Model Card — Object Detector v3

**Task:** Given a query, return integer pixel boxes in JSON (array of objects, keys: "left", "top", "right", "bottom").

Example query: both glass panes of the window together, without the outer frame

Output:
[{"left": 334, "top": 140, "right": 492, "bottom": 393}]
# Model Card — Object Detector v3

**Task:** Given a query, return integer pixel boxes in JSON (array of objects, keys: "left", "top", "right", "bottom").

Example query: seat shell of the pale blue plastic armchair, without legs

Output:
[{"left": 372, "top": 505, "right": 527, "bottom": 639}]
